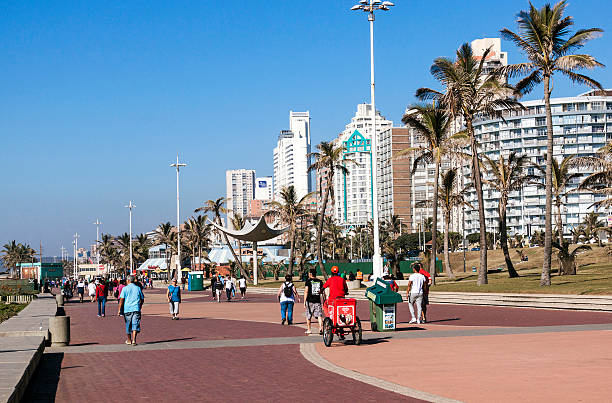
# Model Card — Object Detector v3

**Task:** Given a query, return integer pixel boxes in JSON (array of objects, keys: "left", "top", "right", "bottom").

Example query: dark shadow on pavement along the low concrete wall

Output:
[{"left": 21, "top": 353, "right": 64, "bottom": 402}]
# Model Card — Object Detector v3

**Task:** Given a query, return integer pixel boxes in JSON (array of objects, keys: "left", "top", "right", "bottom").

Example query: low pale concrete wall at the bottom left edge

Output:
[{"left": 0, "top": 294, "right": 57, "bottom": 403}]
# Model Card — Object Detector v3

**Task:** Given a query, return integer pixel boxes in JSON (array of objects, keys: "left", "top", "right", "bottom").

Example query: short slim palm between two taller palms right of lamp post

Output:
[{"left": 438, "top": 168, "right": 470, "bottom": 279}]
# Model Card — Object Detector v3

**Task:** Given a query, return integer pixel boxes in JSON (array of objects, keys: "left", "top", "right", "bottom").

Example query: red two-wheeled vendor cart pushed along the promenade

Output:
[{"left": 323, "top": 298, "right": 362, "bottom": 347}]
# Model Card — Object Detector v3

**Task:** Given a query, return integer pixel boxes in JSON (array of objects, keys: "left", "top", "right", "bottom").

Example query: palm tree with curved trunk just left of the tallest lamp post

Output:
[{"left": 308, "top": 141, "right": 358, "bottom": 279}]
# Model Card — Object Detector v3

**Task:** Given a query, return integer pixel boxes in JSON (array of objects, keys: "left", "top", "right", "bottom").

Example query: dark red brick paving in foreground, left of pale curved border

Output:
[{"left": 24, "top": 345, "right": 419, "bottom": 403}]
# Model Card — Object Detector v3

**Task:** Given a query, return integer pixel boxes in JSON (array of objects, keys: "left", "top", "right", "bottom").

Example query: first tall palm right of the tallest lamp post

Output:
[{"left": 397, "top": 105, "right": 465, "bottom": 284}]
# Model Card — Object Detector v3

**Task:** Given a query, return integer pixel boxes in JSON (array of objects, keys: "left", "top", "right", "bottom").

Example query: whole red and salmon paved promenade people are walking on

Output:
[{"left": 25, "top": 290, "right": 612, "bottom": 402}]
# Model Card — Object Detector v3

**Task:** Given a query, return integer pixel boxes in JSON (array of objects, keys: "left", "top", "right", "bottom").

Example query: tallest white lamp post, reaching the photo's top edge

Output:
[{"left": 351, "top": 0, "right": 394, "bottom": 277}]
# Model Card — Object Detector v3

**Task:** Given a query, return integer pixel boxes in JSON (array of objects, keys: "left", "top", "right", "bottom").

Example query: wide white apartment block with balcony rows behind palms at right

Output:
[{"left": 464, "top": 90, "right": 612, "bottom": 236}]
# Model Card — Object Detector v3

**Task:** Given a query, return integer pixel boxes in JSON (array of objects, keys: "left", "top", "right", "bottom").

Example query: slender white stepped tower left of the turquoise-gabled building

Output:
[{"left": 273, "top": 111, "right": 312, "bottom": 198}]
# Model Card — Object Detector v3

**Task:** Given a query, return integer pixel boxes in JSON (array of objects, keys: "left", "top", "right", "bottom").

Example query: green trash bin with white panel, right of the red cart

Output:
[{"left": 366, "top": 279, "right": 402, "bottom": 332}]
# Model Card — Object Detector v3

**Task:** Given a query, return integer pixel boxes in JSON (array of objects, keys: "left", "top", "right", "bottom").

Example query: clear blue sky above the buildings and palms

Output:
[{"left": 0, "top": 0, "right": 612, "bottom": 255}]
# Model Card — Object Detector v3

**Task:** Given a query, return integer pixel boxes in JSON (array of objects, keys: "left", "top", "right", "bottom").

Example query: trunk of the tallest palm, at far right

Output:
[{"left": 540, "top": 74, "right": 554, "bottom": 286}]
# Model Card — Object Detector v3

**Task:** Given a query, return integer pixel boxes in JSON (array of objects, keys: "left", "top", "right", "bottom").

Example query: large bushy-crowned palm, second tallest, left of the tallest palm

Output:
[{"left": 416, "top": 43, "right": 522, "bottom": 285}]
